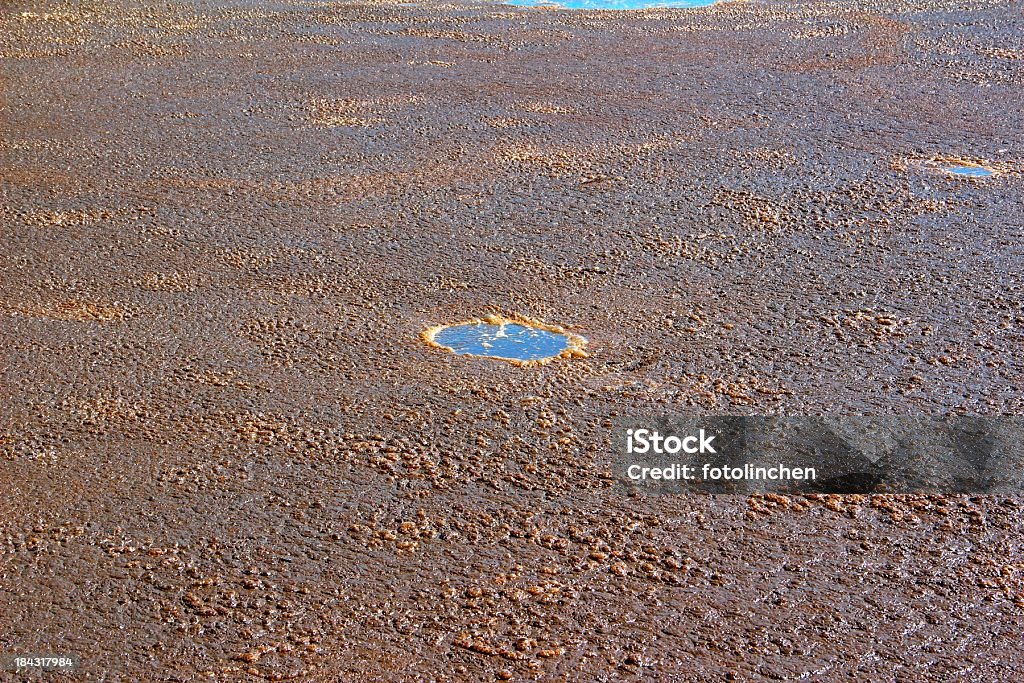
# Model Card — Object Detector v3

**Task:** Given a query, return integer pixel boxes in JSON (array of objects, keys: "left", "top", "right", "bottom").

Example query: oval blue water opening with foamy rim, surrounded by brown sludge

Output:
[{"left": 433, "top": 323, "right": 570, "bottom": 361}]
